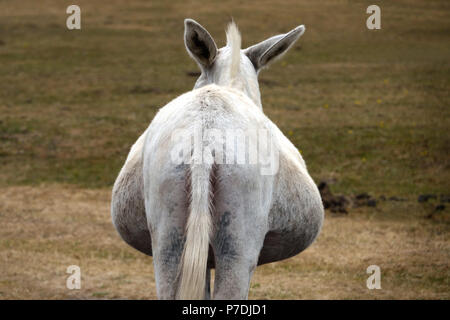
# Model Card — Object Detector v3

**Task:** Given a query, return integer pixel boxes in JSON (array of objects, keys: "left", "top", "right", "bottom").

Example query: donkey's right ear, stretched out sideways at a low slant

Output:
[{"left": 244, "top": 25, "right": 305, "bottom": 71}]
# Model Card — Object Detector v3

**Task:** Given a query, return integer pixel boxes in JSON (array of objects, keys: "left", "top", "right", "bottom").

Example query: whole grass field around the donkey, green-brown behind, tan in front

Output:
[{"left": 0, "top": 0, "right": 450, "bottom": 299}]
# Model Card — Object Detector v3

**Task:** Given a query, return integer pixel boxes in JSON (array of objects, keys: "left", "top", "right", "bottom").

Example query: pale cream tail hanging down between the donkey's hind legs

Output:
[{"left": 177, "top": 163, "right": 212, "bottom": 300}]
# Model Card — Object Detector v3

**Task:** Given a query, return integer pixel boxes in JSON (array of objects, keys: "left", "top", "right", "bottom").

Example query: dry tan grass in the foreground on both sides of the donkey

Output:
[{"left": 0, "top": 185, "right": 450, "bottom": 299}]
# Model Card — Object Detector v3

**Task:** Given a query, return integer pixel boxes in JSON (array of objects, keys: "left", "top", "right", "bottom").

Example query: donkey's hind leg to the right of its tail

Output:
[{"left": 212, "top": 168, "right": 267, "bottom": 300}]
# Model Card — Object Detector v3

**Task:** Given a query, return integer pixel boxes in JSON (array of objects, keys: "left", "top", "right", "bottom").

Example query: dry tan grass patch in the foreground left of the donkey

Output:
[{"left": 0, "top": 186, "right": 156, "bottom": 299}]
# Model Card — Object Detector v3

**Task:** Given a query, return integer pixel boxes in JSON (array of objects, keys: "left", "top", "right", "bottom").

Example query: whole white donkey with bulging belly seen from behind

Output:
[{"left": 111, "top": 19, "right": 324, "bottom": 299}]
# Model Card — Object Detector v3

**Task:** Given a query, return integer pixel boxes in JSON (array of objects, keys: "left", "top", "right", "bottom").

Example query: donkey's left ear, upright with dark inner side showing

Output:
[{"left": 184, "top": 19, "right": 217, "bottom": 67}]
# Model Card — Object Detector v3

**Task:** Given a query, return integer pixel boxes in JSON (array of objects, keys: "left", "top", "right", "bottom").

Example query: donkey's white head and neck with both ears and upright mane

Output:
[{"left": 184, "top": 19, "right": 305, "bottom": 107}]
